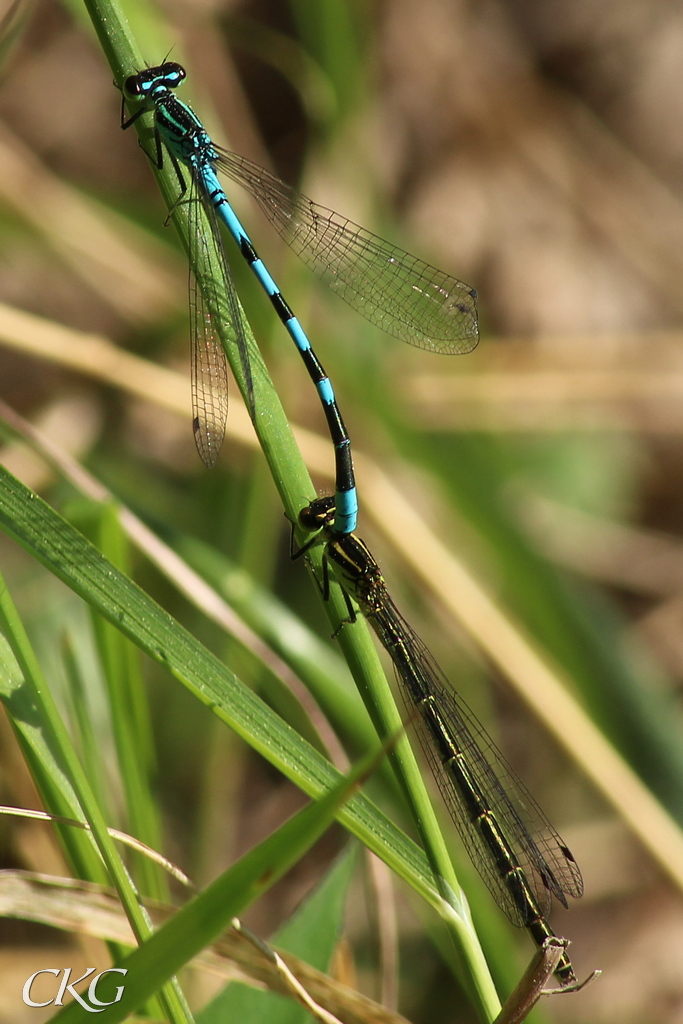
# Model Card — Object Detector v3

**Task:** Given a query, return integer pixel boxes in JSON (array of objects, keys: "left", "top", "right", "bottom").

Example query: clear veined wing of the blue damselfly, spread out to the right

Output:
[{"left": 216, "top": 147, "right": 479, "bottom": 354}]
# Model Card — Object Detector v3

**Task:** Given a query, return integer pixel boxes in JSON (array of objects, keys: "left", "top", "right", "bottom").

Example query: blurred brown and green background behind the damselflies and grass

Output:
[{"left": 0, "top": 0, "right": 683, "bottom": 1024}]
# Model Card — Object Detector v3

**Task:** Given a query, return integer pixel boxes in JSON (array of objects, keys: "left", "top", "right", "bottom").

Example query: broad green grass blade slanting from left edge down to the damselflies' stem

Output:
[{"left": 0, "top": 467, "right": 417, "bottom": 899}]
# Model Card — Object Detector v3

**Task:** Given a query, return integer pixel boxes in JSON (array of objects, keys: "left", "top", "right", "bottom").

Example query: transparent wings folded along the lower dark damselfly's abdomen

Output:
[{"left": 370, "top": 595, "right": 584, "bottom": 927}]
